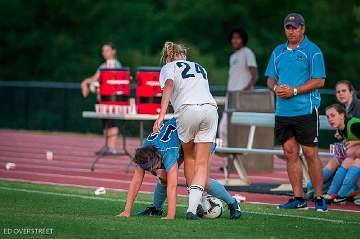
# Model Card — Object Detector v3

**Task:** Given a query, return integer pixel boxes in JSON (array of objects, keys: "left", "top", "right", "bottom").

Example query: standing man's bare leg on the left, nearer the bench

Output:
[{"left": 283, "top": 137, "right": 304, "bottom": 197}]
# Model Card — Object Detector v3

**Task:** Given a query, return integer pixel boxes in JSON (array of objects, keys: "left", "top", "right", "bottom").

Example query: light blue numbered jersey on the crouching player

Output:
[{"left": 144, "top": 118, "right": 182, "bottom": 172}]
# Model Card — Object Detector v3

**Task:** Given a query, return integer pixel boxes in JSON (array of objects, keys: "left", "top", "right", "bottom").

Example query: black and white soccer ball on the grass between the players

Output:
[{"left": 198, "top": 195, "right": 224, "bottom": 219}]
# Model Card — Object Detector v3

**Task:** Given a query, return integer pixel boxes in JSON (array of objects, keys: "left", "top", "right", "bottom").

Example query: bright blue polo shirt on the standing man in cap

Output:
[{"left": 265, "top": 36, "right": 326, "bottom": 117}]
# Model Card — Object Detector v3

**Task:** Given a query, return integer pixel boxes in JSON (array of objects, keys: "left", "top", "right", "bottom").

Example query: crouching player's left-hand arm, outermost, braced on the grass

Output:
[{"left": 118, "top": 168, "right": 145, "bottom": 217}]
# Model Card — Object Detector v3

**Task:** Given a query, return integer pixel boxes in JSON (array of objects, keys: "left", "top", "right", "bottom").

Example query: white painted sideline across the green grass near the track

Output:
[{"left": 0, "top": 186, "right": 360, "bottom": 225}]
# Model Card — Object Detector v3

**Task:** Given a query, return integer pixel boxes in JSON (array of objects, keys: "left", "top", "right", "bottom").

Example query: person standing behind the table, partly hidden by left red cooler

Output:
[{"left": 81, "top": 43, "right": 121, "bottom": 155}]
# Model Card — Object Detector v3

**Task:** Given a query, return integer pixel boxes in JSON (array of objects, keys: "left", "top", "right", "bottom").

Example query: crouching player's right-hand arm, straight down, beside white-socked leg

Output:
[{"left": 166, "top": 163, "right": 178, "bottom": 219}]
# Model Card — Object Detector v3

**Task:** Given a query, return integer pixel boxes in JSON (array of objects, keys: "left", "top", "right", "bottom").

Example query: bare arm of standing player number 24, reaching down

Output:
[{"left": 153, "top": 79, "right": 174, "bottom": 133}]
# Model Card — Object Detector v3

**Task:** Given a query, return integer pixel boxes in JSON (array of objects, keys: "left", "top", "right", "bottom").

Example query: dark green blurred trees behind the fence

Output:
[{"left": 0, "top": 0, "right": 360, "bottom": 88}]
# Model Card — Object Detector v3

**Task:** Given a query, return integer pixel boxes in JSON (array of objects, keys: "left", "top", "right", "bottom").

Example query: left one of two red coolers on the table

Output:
[{"left": 99, "top": 68, "right": 130, "bottom": 105}]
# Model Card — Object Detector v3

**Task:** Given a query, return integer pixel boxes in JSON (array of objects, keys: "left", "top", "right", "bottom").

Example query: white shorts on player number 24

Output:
[{"left": 175, "top": 104, "right": 219, "bottom": 143}]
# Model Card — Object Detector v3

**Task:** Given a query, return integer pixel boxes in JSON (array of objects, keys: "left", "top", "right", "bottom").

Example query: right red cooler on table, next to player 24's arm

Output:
[{"left": 136, "top": 67, "right": 162, "bottom": 114}]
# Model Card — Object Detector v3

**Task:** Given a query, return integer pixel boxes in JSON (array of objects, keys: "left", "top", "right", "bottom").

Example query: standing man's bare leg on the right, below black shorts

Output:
[{"left": 301, "top": 145, "right": 323, "bottom": 197}]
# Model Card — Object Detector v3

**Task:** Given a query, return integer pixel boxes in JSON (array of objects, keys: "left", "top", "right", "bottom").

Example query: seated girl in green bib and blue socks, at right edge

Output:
[{"left": 325, "top": 104, "right": 360, "bottom": 203}]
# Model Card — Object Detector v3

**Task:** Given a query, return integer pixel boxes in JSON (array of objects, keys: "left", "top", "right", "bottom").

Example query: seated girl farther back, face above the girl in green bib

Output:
[{"left": 307, "top": 80, "right": 360, "bottom": 198}]
